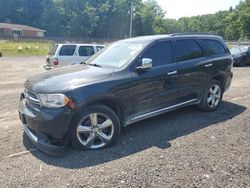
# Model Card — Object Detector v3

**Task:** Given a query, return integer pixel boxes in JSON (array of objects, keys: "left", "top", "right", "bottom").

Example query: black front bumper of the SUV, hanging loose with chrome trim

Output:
[{"left": 19, "top": 93, "right": 73, "bottom": 155}]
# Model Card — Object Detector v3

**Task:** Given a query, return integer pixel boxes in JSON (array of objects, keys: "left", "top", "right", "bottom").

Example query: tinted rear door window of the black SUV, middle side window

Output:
[{"left": 175, "top": 39, "right": 203, "bottom": 61}]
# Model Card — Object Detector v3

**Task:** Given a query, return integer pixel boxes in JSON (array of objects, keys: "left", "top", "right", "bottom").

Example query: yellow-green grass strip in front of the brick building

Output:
[{"left": 0, "top": 40, "right": 53, "bottom": 56}]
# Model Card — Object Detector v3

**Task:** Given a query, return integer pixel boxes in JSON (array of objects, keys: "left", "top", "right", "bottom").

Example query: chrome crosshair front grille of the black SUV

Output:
[{"left": 24, "top": 89, "right": 41, "bottom": 112}]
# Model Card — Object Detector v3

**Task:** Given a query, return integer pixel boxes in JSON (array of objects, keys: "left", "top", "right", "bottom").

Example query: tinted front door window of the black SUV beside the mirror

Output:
[{"left": 143, "top": 41, "right": 173, "bottom": 67}]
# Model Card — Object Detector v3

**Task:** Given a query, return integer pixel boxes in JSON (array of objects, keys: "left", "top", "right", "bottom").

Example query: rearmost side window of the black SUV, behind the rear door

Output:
[{"left": 202, "top": 39, "right": 227, "bottom": 55}]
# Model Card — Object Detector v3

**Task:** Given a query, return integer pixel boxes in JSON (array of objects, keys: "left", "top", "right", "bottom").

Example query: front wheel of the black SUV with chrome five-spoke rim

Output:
[{"left": 70, "top": 104, "right": 121, "bottom": 150}]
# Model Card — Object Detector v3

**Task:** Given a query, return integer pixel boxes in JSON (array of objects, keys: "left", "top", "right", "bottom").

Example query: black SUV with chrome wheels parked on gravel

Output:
[{"left": 19, "top": 34, "right": 233, "bottom": 155}]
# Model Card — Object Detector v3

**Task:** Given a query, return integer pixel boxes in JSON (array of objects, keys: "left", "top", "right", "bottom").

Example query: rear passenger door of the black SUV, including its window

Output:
[{"left": 174, "top": 38, "right": 208, "bottom": 103}]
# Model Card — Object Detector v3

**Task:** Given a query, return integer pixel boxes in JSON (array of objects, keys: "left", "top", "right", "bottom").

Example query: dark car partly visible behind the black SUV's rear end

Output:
[{"left": 230, "top": 46, "right": 250, "bottom": 66}]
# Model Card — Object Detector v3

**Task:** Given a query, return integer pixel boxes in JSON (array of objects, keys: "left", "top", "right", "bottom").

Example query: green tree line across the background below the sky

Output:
[{"left": 0, "top": 0, "right": 250, "bottom": 40}]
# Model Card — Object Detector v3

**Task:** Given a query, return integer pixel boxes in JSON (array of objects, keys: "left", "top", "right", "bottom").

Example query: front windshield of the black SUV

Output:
[{"left": 86, "top": 42, "right": 146, "bottom": 68}]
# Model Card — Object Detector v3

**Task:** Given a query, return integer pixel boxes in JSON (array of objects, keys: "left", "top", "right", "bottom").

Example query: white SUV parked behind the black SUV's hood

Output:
[{"left": 44, "top": 44, "right": 104, "bottom": 70}]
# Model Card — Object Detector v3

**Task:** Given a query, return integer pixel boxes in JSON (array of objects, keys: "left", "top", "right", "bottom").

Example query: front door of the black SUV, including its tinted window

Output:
[{"left": 132, "top": 41, "right": 178, "bottom": 116}]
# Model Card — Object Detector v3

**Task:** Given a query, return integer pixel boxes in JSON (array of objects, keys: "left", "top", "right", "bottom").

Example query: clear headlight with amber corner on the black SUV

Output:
[{"left": 39, "top": 94, "right": 69, "bottom": 108}]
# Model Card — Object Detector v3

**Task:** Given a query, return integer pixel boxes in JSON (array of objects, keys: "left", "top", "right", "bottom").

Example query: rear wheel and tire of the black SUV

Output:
[{"left": 198, "top": 80, "right": 223, "bottom": 112}]
